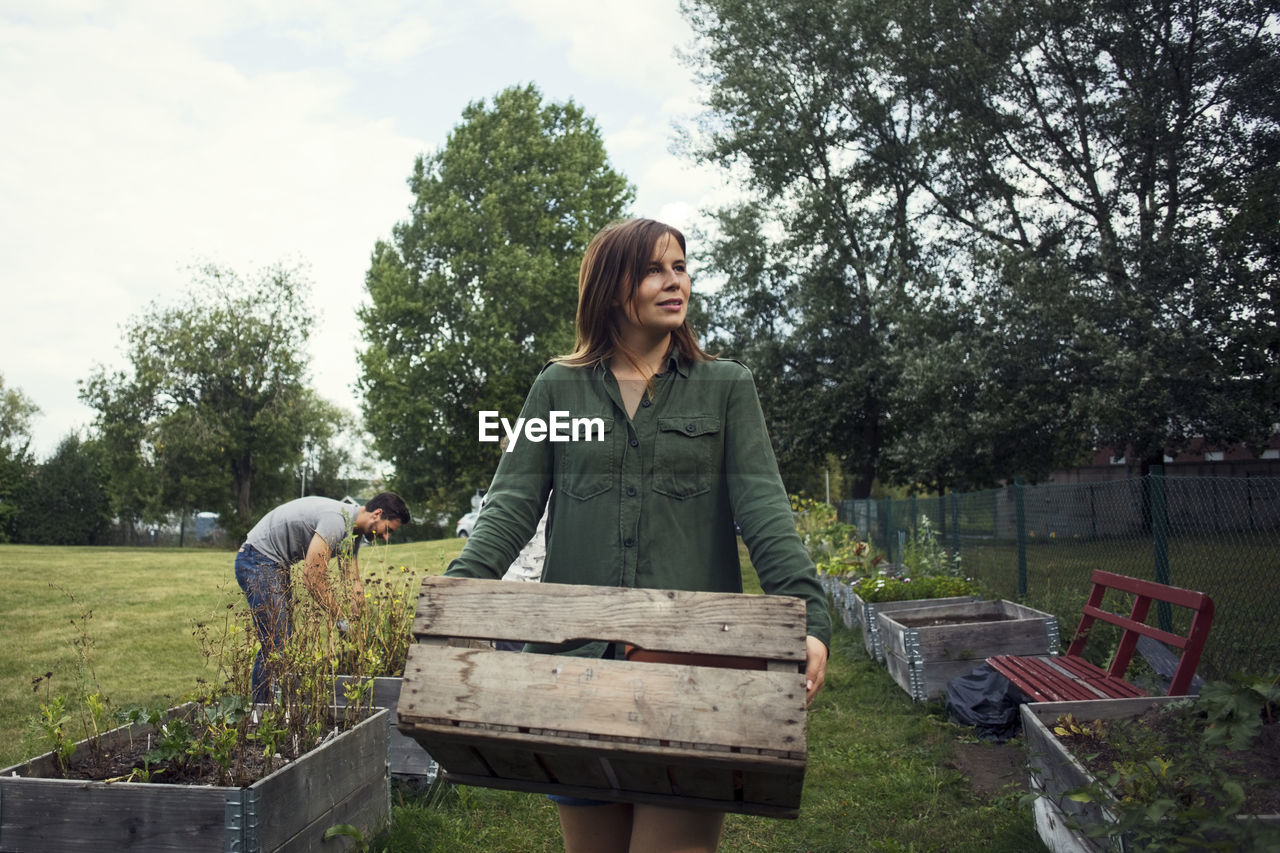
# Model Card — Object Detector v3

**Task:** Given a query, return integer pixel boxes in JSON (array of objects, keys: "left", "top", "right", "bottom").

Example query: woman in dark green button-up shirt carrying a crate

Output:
[{"left": 447, "top": 219, "right": 831, "bottom": 853}]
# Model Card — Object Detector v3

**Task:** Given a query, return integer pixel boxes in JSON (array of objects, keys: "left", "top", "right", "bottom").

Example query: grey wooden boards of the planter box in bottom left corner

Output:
[{"left": 0, "top": 711, "right": 390, "bottom": 853}]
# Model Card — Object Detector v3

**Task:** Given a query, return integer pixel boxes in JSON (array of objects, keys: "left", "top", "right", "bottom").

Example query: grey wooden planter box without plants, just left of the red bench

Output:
[{"left": 876, "top": 601, "right": 1059, "bottom": 702}]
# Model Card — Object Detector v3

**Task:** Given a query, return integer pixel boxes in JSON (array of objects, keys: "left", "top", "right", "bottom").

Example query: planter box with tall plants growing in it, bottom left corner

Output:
[{"left": 0, "top": 581, "right": 389, "bottom": 852}]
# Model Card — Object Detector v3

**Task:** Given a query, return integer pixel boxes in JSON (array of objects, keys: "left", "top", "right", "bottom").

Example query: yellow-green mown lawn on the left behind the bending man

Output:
[{"left": 0, "top": 539, "right": 462, "bottom": 767}]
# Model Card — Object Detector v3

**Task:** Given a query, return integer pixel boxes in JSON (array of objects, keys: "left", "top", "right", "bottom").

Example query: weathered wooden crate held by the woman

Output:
[{"left": 398, "top": 578, "right": 805, "bottom": 817}]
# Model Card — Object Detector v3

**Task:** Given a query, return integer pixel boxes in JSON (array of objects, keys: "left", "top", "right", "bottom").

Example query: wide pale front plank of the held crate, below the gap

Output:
[{"left": 398, "top": 646, "right": 805, "bottom": 762}]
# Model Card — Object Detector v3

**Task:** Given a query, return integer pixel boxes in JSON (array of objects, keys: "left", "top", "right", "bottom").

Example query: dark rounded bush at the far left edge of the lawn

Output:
[{"left": 17, "top": 433, "right": 111, "bottom": 544}]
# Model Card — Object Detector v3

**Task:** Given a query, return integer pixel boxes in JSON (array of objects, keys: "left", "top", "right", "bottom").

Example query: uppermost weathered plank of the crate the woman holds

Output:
[{"left": 413, "top": 576, "right": 805, "bottom": 662}]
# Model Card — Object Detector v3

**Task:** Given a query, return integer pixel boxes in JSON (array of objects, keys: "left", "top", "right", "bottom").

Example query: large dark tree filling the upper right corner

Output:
[{"left": 901, "top": 0, "right": 1280, "bottom": 469}]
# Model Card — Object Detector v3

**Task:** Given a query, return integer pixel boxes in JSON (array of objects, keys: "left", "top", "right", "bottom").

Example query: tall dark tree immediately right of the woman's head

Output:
[{"left": 685, "top": 0, "right": 945, "bottom": 497}]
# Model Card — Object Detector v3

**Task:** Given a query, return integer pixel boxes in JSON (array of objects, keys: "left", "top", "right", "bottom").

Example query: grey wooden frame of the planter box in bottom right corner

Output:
[{"left": 1019, "top": 695, "right": 1280, "bottom": 853}]
